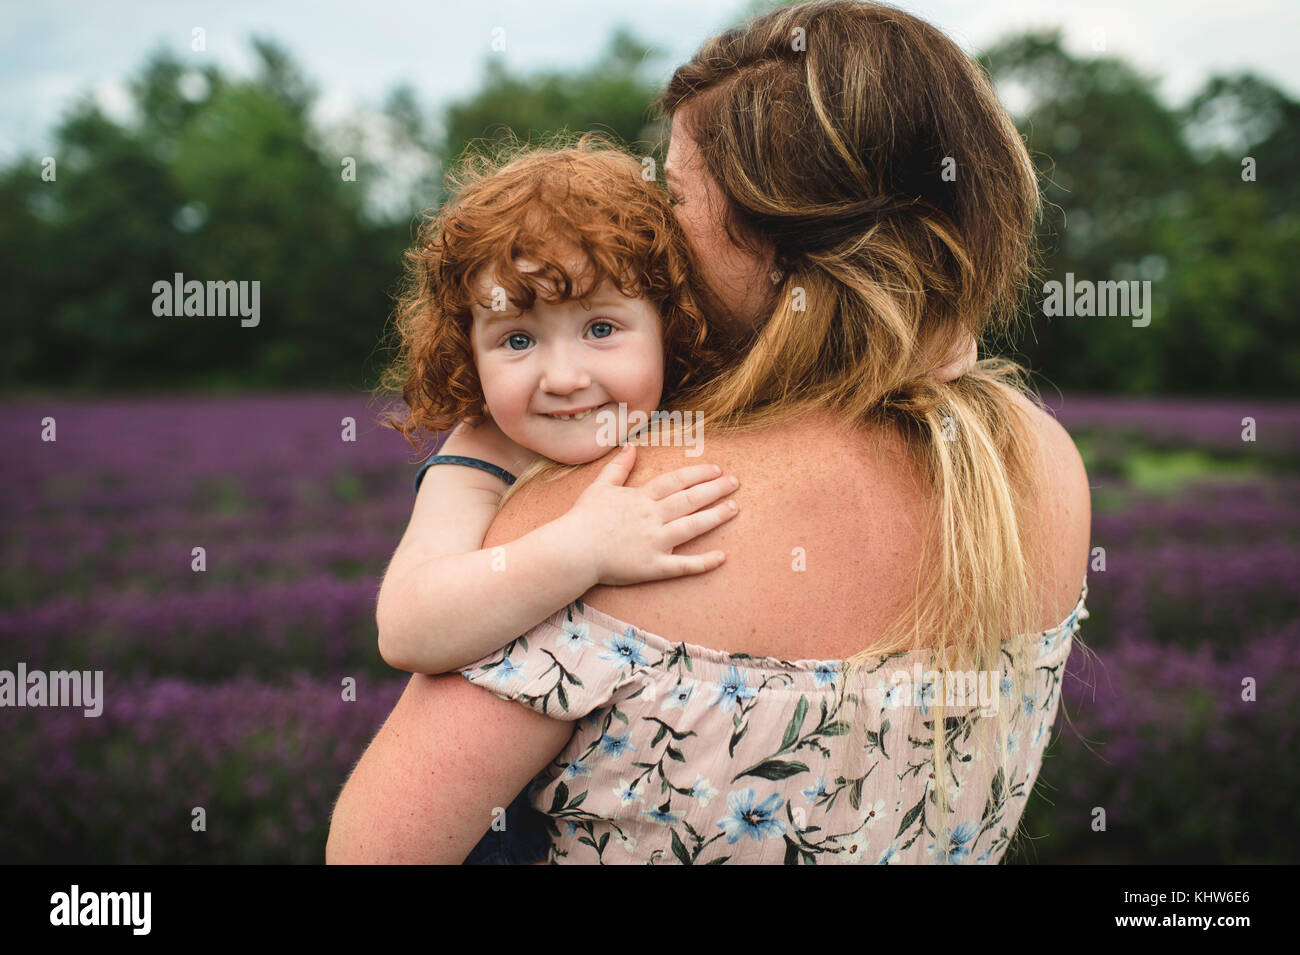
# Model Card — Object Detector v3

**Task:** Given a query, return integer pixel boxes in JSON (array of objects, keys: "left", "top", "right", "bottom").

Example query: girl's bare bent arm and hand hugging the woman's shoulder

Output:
[{"left": 376, "top": 420, "right": 736, "bottom": 673}]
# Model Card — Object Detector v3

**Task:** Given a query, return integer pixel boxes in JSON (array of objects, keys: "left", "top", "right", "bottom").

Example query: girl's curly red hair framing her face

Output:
[{"left": 381, "top": 134, "right": 725, "bottom": 450}]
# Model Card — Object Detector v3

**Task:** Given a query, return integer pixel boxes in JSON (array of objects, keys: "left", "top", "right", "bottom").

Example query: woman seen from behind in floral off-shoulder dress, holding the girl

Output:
[{"left": 326, "top": 1, "right": 1089, "bottom": 864}]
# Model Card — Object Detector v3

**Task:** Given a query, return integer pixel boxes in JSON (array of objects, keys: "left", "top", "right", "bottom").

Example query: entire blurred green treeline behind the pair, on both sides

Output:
[{"left": 0, "top": 26, "right": 1300, "bottom": 395}]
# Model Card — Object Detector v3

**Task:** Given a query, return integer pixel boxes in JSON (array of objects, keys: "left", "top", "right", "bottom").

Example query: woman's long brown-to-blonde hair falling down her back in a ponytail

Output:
[{"left": 512, "top": 0, "right": 1041, "bottom": 859}]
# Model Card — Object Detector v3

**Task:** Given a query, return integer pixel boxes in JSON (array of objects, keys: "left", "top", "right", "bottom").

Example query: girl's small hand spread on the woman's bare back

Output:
[{"left": 560, "top": 444, "right": 740, "bottom": 586}]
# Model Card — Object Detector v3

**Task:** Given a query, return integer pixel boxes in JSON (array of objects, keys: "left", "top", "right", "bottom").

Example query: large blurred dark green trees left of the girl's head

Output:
[{"left": 0, "top": 40, "right": 404, "bottom": 390}]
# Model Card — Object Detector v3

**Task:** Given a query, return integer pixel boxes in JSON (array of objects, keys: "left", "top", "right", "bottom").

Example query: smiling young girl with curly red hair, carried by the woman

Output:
[{"left": 376, "top": 136, "right": 737, "bottom": 861}]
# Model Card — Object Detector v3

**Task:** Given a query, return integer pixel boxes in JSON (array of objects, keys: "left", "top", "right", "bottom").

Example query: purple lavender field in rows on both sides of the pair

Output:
[{"left": 0, "top": 395, "right": 1300, "bottom": 863}]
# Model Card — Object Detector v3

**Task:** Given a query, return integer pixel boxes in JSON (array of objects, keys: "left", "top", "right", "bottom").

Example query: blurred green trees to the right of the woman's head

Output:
[{"left": 983, "top": 31, "right": 1300, "bottom": 395}]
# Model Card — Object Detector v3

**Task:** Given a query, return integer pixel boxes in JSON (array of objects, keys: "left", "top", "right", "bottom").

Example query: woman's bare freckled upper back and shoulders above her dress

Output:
[{"left": 485, "top": 399, "right": 1091, "bottom": 659}]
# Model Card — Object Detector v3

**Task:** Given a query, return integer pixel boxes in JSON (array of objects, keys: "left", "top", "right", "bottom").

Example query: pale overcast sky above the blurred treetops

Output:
[{"left": 0, "top": 0, "right": 1300, "bottom": 161}]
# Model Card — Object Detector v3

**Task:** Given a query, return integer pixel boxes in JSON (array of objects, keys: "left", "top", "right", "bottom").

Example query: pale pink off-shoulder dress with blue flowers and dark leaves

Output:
[{"left": 460, "top": 579, "right": 1088, "bottom": 865}]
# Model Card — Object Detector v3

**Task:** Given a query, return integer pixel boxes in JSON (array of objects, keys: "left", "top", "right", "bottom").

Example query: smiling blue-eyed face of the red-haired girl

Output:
[{"left": 471, "top": 259, "right": 663, "bottom": 464}]
